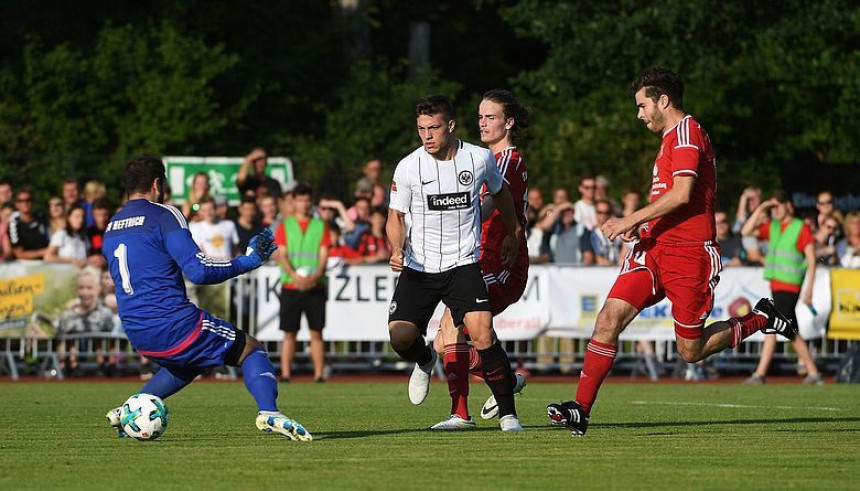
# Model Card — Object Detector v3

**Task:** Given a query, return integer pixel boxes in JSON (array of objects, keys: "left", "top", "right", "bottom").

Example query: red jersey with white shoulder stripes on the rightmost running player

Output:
[{"left": 645, "top": 115, "right": 717, "bottom": 244}]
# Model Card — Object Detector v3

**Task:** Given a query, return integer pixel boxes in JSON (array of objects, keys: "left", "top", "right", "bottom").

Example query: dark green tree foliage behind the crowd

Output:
[{"left": 0, "top": 0, "right": 860, "bottom": 206}]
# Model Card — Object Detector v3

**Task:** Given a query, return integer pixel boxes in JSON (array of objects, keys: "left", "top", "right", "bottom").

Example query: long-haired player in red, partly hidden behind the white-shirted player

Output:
[{"left": 420, "top": 89, "right": 529, "bottom": 430}]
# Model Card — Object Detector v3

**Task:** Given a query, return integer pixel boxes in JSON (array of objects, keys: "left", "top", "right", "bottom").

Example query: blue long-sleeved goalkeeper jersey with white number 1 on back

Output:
[{"left": 102, "top": 199, "right": 258, "bottom": 353}]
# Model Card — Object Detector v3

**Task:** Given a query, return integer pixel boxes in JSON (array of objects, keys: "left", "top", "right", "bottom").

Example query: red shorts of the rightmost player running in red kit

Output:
[{"left": 609, "top": 240, "right": 723, "bottom": 339}]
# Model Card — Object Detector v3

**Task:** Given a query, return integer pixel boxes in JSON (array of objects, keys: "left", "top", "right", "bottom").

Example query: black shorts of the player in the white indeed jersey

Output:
[{"left": 388, "top": 264, "right": 492, "bottom": 334}]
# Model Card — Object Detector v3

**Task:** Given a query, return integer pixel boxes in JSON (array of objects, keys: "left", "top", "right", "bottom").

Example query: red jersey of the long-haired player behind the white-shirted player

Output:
[{"left": 481, "top": 147, "right": 529, "bottom": 276}]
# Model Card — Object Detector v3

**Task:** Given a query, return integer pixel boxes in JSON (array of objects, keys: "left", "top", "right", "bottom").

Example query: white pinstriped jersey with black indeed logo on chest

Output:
[{"left": 389, "top": 141, "right": 503, "bottom": 273}]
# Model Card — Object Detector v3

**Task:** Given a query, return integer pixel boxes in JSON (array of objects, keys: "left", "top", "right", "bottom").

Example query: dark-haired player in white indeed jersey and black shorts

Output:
[{"left": 386, "top": 95, "right": 523, "bottom": 431}]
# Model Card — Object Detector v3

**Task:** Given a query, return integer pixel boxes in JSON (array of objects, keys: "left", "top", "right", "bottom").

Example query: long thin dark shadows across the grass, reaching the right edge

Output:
[{"left": 314, "top": 418, "right": 860, "bottom": 440}]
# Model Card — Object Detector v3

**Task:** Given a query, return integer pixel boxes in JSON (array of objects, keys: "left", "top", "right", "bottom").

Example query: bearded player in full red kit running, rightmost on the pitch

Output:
[{"left": 547, "top": 67, "right": 797, "bottom": 436}]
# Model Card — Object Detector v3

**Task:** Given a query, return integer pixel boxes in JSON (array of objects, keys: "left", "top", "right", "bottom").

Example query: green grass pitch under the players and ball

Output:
[{"left": 0, "top": 376, "right": 860, "bottom": 490}]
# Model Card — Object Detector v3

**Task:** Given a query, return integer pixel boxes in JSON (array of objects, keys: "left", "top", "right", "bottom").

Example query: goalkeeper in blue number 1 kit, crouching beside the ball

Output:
[{"left": 102, "top": 157, "right": 312, "bottom": 441}]
